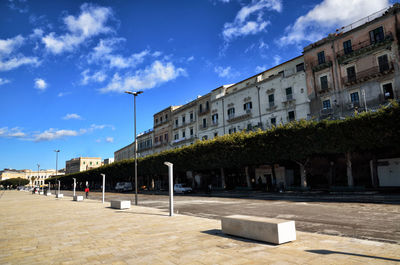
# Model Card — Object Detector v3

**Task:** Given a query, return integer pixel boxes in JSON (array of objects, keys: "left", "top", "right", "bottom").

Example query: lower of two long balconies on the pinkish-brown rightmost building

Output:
[{"left": 342, "top": 63, "right": 394, "bottom": 86}]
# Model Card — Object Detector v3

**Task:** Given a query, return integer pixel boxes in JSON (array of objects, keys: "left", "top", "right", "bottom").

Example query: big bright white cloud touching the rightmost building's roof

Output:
[{"left": 279, "top": 0, "right": 389, "bottom": 45}]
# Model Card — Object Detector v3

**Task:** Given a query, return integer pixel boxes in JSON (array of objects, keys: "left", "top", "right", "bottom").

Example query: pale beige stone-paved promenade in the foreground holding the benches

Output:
[{"left": 0, "top": 191, "right": 400, "bottom": 264}]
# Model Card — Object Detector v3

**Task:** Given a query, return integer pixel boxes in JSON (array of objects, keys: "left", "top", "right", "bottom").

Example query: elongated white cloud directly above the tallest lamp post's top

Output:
[{"left": 100, "top": 60, "right": 186, "bottom": 93}]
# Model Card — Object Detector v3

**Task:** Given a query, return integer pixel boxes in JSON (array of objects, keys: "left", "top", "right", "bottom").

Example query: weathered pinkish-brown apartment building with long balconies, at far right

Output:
[{"left": 303, "top": 4, "right": 400, "bottom": 119}]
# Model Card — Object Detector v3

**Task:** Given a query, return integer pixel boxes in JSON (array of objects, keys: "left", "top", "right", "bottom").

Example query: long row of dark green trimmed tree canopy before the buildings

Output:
[{"left": 50, "top": 102, "right": 400, "bottom": 186}]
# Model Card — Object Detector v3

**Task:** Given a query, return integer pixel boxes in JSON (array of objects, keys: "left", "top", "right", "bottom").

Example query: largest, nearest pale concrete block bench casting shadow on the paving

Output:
[{"left": 221, "top": 215, "right": 296, "bottom": 245}]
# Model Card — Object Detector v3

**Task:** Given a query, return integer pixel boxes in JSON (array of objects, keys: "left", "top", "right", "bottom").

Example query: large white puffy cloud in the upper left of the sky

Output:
[{"left": 42, "top": 4, "right": 112, "bottom": 54}]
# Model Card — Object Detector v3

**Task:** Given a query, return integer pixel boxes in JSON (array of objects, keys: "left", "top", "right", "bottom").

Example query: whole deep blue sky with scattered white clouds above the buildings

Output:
[{"left": 0, "top": 0, "right": 393, "bottom": 170}]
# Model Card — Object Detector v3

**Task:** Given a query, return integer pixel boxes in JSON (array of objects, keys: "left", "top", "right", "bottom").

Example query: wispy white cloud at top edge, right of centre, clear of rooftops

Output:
[{"left": 222, "top": 0, "right": 282, "bottom": 41}]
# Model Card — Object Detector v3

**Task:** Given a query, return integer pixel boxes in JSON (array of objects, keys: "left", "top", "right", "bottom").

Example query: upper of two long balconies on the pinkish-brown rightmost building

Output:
[{"left": 336, "top": 32, "right": 393, "bottom": 64}]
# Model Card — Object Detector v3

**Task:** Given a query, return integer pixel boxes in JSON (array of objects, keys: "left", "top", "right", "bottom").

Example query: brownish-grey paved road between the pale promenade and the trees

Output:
[{"left": 63, "top": 191, "right": 400, "bottom": 244}]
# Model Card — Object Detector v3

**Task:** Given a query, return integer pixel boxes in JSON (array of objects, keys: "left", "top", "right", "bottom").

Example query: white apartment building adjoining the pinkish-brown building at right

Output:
[{"left": 199, "top": 56, "right": 310, "bottom": 140}]
